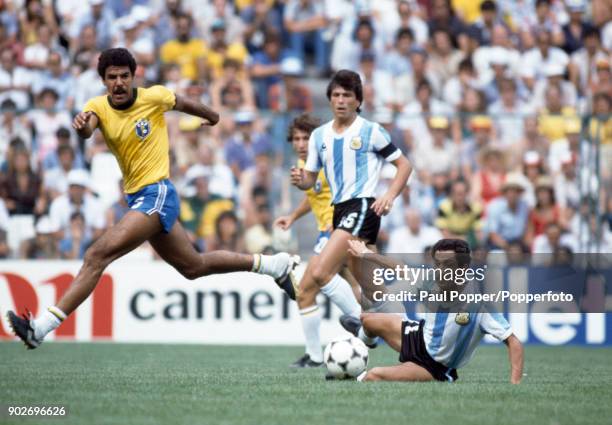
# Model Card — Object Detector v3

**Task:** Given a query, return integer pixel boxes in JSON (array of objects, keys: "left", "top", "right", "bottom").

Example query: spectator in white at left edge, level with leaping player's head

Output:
[{"left": 0, "top": 50, "right": 32, "bottom": 111}]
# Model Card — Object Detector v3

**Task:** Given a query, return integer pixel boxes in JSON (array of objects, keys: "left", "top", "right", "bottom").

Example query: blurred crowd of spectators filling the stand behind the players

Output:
[{"left": 0, "top": 0, "right": 612, "bottom": 259}]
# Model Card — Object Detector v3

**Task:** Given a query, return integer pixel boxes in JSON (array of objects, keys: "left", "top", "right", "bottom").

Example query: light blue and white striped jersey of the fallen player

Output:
[{"left": 416, "top": 311, "right": 512, "bottom": 369}]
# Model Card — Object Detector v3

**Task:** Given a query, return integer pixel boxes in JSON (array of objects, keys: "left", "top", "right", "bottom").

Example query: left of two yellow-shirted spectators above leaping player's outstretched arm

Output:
[{"left": 159, "top": 14, "right": 207, "bottom": 80}]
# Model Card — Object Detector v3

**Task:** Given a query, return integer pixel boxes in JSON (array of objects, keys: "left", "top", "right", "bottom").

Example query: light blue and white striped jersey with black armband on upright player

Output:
[{"left": 304, "top": 116, "right": 401, "bottom": 204}]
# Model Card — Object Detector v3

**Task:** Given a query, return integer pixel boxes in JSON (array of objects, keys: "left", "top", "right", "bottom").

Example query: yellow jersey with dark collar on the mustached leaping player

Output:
[{"left": 83, "top": 86, "right": 176, "bottom": 193}]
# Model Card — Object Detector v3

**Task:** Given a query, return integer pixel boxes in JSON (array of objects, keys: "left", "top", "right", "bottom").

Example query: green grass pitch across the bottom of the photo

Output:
[{"left": 0, "top": 342, "right": 612, "bottom": 425}]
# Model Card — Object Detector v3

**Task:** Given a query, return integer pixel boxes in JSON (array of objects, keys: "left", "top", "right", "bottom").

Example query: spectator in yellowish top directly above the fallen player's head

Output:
[{"left": 434, "top": 179, "right": 483, "bottom": 246}]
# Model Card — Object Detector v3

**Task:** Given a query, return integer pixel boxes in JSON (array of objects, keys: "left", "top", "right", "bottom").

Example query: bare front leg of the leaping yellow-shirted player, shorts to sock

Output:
[{"left": 57, "top": 211, "right": 162, "bottom": 316}]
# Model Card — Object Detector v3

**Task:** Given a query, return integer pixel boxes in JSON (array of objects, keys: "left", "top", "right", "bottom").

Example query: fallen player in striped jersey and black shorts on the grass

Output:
[{"left": 341, "top": 239, "right": 523, "bottom": 384}]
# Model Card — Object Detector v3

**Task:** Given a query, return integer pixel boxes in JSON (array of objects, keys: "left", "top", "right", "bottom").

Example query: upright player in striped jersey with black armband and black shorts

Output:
[{"left": 291, "top": 70, "right": 412, "bottom": 358}]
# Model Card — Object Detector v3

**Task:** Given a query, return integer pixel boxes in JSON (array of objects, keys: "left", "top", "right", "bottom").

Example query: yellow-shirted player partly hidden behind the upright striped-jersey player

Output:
[{"left": 275, "top": 114, "right": 361, "bottom": 368}]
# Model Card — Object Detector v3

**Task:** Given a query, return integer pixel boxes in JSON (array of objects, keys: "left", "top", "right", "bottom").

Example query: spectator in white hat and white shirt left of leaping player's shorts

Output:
[{"left": 49, "top": 170, "right": 106, "bottom": 240}]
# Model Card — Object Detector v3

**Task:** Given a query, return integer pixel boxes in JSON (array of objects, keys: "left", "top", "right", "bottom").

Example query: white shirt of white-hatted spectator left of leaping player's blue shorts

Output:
[{"left": 49, "top": 193, "right": 105, "bottom": 231}]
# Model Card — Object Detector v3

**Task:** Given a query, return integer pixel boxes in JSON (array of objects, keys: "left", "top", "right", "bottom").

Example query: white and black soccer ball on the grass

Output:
[{"left": 323, "top": 336, "right": 368, "bottom": 379}]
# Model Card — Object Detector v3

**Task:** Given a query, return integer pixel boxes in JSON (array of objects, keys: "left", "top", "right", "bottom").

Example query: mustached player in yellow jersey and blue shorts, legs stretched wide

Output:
[{"left": 7, "top": 48, "right": 299, "bottom": 349}]
